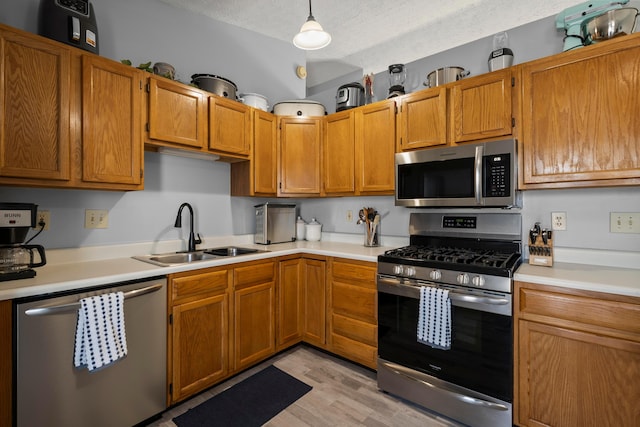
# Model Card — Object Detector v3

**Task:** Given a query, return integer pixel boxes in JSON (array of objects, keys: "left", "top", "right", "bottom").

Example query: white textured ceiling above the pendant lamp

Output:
[{"left": 160, "top": 0, "right": 579, "bottom": 87}]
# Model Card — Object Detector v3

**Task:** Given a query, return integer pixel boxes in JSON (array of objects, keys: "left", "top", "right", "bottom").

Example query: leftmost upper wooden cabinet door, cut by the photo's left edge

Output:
[{"left": 0, "top": 29, "right": 72, "bottom": 183}]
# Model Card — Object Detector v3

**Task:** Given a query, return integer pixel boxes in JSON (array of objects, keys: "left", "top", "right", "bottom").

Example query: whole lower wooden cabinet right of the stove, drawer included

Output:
[{"left": 514, "top": 282, "right": 640, "bottom": 427}]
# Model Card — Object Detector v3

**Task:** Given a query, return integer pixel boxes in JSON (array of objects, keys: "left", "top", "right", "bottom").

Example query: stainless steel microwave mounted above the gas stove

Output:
[{"left": 395, "top": 139, "right": 522, "bottom": 208}]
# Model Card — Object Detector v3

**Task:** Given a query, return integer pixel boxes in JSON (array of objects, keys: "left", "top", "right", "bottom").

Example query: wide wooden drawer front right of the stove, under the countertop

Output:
[{"left": 519, "top": 288, "right": 640, "bottom": 338}]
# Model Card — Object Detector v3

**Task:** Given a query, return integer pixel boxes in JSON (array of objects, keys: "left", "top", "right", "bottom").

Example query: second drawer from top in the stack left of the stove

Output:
[{"left": 331, "top": 282, "right": 377, "bottom": 324}]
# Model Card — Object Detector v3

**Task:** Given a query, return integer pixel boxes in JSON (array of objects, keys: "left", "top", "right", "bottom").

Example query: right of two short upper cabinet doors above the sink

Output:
[{"left": 209, "top": 96, "right": 251, "bottom": 158}]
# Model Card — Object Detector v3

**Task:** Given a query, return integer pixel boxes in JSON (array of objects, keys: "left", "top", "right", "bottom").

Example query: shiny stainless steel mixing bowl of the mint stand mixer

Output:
[{"left": 580, "top": 7, "right": 638, "bottom": 45}]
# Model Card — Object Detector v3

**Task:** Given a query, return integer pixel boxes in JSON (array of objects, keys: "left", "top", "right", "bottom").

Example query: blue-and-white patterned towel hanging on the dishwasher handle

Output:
[{"left": 73, "top": 292, "right": 127, "bottom": 371}]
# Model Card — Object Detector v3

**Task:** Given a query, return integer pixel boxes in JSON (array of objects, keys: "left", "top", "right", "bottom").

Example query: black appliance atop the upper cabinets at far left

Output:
[{"left": 38, "top": 0, "right": 99, "bottom": 54}]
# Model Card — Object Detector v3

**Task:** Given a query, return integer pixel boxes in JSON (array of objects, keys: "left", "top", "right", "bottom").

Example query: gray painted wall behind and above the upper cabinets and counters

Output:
[{"left": 0, "top": 0, "right": 640, "bottom": 251}]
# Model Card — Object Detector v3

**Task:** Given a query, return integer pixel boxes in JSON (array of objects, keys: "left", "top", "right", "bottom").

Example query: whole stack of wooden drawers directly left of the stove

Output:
[{"left": 328, "top": 258, "right": 378, "bottom": 369}]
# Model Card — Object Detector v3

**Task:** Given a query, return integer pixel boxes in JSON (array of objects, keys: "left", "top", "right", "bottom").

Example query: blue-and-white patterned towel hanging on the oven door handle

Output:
[{"left": 418, "top": 286, "right": 451, "bottom": 350}]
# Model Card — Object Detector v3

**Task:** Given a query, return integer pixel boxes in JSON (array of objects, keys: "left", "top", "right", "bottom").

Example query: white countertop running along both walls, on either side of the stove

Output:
[{"left": 0, "top": 233, "right": 640, "bottom": 300}]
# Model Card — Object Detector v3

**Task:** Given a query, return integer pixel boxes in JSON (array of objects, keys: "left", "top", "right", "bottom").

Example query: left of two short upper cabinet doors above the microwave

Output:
[{"left": 397, "top": 88, "right": 449, "bottom": 151}]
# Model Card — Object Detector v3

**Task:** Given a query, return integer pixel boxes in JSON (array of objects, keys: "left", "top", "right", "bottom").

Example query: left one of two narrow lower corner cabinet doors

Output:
[{"left": 277, "top": 258, "right": 304, "bottom": 350}]
